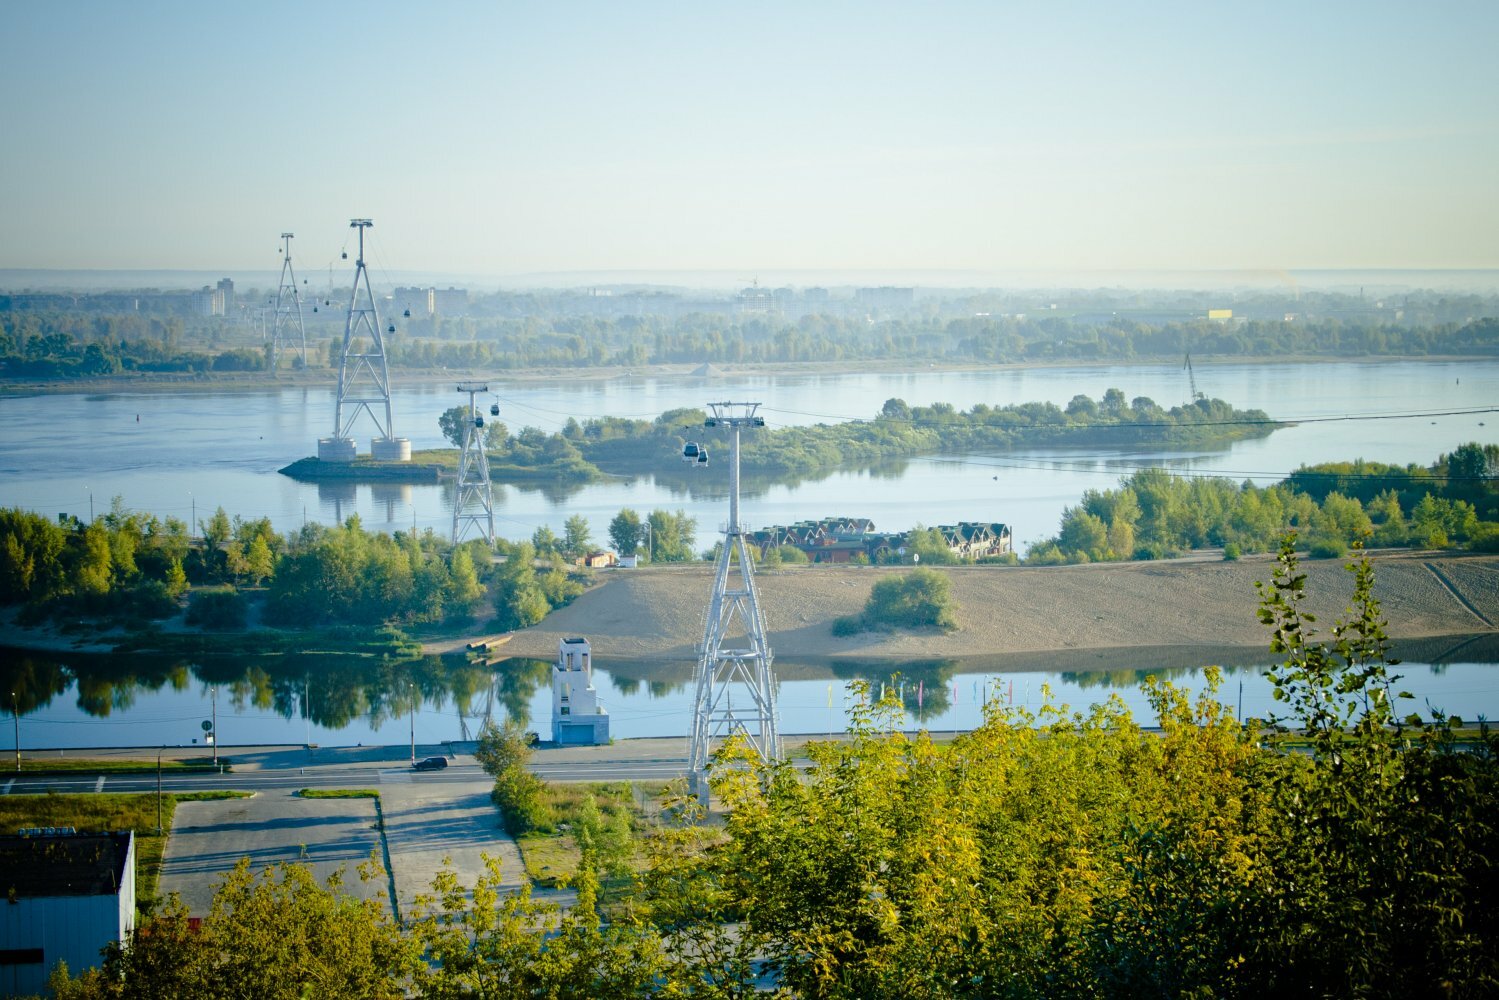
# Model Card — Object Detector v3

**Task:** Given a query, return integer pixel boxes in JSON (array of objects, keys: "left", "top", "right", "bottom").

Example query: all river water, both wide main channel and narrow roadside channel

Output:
[{"left": 0, "top": 361, "right": 1499, "bottom": 748}]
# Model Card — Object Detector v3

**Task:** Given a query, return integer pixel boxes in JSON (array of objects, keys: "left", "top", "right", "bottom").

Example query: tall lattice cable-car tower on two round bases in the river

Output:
[{"left": 318, "top": 219, "right": 411, "bottom": 462}]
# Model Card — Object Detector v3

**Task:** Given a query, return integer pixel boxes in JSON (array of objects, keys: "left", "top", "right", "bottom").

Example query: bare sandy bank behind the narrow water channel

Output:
[{"left": 504, "top": 552, "right": 1499, "bottom": 660}]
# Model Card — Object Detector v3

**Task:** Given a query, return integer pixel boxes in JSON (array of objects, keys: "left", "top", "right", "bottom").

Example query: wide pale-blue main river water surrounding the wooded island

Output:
[{"left": 0, "top": 361, "right": 1499, "bottom": 549}]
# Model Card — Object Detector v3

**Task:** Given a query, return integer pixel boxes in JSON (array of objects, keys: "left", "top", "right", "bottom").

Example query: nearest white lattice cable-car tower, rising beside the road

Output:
[{"left": 688, "top": 403, "right": 781, "bottom": 804}]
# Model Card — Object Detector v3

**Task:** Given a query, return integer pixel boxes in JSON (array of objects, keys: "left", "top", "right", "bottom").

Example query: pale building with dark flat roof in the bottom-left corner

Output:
[{"left": 0, "top": 829, "right": 135, "bottom": 997}]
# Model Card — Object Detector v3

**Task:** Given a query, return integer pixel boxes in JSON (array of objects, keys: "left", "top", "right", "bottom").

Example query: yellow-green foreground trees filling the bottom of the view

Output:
[{"left": 41, "top": 540, "right": 1499, "bottom": 1000}]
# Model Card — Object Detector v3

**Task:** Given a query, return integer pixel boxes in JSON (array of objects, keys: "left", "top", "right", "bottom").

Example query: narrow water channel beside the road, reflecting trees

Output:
[{"left": 0, "top": 633, "right": 1499, "bottom": 747}]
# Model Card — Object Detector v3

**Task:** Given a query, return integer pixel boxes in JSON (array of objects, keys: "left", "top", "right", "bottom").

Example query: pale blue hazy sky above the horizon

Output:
[{"left": 0, "top": 0, "right": 1499, "bottom": 279}]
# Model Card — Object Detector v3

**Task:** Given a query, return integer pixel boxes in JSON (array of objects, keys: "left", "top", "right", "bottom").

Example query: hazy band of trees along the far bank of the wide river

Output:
[{"left": 0, "top": 302, "right": 1499, "bottom": 378}]
